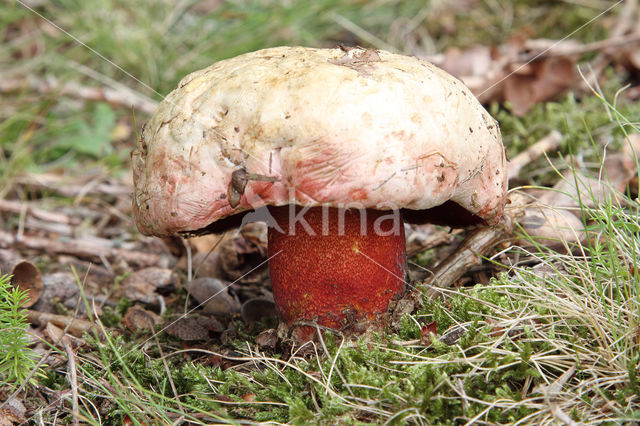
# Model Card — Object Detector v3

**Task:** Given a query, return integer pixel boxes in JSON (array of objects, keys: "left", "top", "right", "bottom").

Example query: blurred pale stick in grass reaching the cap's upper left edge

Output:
[{"left": 0, "top": 76, "right": 158, "bottom": 114}]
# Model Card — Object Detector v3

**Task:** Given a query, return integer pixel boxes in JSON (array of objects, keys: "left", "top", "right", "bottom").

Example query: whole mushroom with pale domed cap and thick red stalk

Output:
[{"left": 132, "top": 47, "right": 507, "bottom": 327}]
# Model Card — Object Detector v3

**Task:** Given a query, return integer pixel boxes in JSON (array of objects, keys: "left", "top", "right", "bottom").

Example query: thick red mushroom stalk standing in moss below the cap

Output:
[{"left": 268, "top": 205, "right": 407, "bottom": 328}]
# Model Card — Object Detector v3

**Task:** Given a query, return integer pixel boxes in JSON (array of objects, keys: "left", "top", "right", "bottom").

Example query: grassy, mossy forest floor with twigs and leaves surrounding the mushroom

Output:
[{"left": 0, "top": 0, "right": 640, "bottom": 425}]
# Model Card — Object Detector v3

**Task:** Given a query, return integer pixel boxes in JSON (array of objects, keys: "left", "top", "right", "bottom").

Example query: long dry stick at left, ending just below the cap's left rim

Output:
[{"left": 0, "top": 230, "right": 160, "bottom": 267}]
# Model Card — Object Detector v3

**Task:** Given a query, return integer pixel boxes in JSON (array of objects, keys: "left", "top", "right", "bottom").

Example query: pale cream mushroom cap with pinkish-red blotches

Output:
[{"left": 132, "top": 47, "right": 507, "bottom": 235}]
